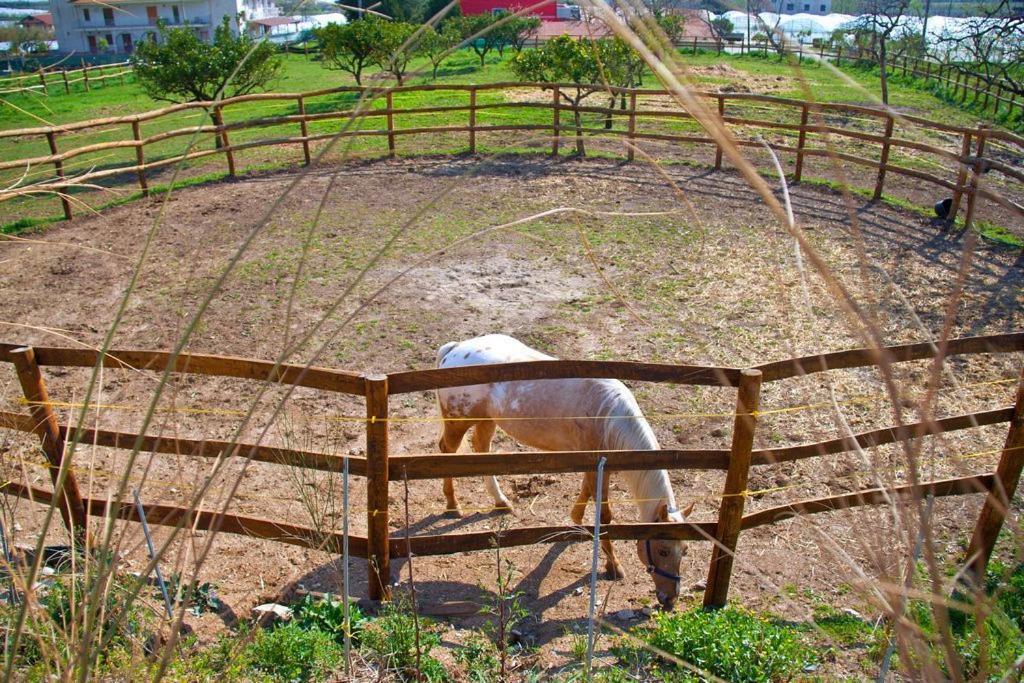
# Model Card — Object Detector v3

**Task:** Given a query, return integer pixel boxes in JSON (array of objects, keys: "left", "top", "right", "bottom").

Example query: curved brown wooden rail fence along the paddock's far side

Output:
[{"left": 0, "top": 83, "right": 1024, "bottom": 231}]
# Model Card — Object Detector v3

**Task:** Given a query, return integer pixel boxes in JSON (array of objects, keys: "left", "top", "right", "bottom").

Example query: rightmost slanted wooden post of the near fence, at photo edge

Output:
[{"left": 967, "top": 370, "right": 1024, "bottom": 586}]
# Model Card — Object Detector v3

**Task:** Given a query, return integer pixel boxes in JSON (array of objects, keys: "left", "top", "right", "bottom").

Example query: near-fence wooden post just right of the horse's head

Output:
[{"left": 703, "top": 370, "right": 761, "bottom": 607}]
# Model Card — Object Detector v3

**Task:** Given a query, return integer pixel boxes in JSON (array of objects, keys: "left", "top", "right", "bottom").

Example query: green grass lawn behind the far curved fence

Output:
[{"left": 0, "top": 45, "right": 1015, "bottom": 232}]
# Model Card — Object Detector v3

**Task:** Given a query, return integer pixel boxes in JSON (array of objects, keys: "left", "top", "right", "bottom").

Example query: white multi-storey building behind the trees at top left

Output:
[{"left": 50, "top": 0, "right": 278, "bottom": 54}]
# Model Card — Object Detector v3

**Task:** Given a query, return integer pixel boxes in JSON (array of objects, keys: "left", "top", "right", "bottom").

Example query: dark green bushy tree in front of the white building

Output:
[{"left": 131, "top": 16, "right": 281, "bottom": 123}]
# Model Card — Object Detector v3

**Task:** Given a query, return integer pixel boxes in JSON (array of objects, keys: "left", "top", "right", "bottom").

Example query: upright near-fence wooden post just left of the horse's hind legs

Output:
[{"left": 365, "top": 375, "right": 391, "bottom": 600}]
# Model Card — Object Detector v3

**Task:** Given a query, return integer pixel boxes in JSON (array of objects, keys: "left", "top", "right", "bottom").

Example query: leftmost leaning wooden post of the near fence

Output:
[{"left": 10, "top": 346, "right": 89, "bottom": 544}]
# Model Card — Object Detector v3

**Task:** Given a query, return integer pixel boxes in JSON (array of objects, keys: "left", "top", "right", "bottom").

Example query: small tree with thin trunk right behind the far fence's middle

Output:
[{"left": 510, "top": 36, "right": 622, "bottom": 157}]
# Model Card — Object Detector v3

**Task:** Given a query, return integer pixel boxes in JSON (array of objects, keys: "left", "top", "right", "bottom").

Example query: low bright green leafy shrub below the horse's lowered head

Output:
[{"left": 620, "top": 607, "right": 815, "bottom": 682}]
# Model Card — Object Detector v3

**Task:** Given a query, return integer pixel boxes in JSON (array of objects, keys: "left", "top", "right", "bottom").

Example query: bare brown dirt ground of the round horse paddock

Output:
[{"left": 0, "top": 157, "right": 1024, "bottom": 677}]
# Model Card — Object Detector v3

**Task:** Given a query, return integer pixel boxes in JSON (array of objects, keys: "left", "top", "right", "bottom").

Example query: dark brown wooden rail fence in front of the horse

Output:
[{"left": 0, "top": 333, "right": 1024, "bottom": 605}]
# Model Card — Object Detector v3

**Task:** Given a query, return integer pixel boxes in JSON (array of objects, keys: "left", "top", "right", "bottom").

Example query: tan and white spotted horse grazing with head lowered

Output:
[{"left": 437, "top": 335, "right": 692, "bottom": 609}]
